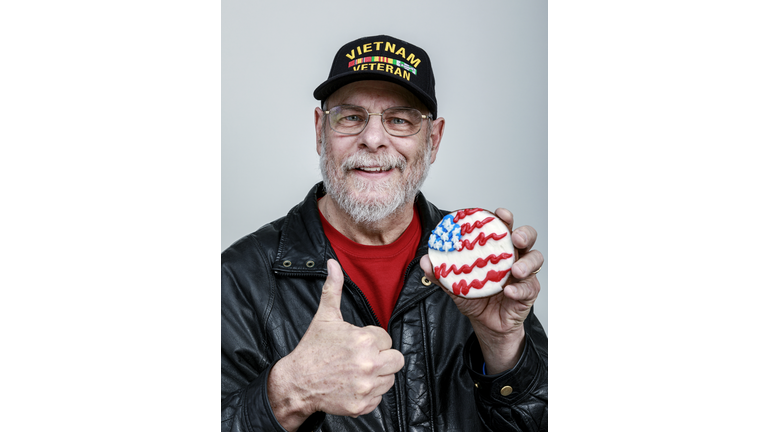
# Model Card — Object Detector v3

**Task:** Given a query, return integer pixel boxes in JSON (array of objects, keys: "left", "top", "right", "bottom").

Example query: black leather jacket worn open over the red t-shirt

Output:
[{"left": 221, "top": 183, "right": 547, "bottom": 431}]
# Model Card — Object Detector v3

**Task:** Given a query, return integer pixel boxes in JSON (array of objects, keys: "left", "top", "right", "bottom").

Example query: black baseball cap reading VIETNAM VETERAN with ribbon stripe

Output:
[{"left": 314, "top": 35, "right": 437, "bottom": 118}]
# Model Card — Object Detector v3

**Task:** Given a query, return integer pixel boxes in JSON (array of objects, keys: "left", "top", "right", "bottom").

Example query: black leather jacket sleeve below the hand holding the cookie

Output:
[{"left": 464, "top": 311, "right": 548, "bottom": 432}]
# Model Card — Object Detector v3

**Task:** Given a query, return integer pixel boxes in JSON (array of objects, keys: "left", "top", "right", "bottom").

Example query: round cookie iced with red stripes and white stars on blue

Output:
[{"left": 429, "top": 208, "right": 515, "bottom": 298}]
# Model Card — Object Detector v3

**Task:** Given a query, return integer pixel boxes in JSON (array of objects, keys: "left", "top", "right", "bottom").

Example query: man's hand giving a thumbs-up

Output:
[{"left": 268, "top": 260, "right": 405, "bottom": 431}]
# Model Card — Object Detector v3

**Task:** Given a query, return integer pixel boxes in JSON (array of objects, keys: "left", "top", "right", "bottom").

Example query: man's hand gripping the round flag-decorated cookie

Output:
[{"left": 420, "top": 208, "right": 544, "bottom": 374}]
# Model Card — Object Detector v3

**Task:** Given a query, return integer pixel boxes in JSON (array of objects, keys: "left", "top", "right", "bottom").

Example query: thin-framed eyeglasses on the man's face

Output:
[{"left": 324, "top": 105, "right": 432, "bottom": 137}]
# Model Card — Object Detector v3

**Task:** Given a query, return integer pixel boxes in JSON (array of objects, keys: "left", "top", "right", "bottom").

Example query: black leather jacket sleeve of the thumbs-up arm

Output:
[{"left": 221, "top": 241, "right": 325, "bottom": 432}]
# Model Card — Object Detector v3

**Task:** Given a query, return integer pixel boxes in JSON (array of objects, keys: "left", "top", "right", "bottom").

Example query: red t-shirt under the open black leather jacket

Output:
[{"left": 320, "top": 206, "right": 421, "bottom": 330}]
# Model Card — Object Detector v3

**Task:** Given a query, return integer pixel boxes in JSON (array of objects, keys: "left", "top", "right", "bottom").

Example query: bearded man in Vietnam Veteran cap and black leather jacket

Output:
[{"left": 221, "top": 35, "right": 547, "bottom": 431}]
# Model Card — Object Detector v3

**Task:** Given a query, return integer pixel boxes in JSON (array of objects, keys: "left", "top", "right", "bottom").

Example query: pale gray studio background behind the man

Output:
[{"left": 221, "top": 0, "right": 548, "bottom": 329}]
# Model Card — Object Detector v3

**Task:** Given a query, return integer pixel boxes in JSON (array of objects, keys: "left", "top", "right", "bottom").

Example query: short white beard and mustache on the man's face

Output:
[{"left": 320, "top": 137, "right": 432, "bottom": 223}]
